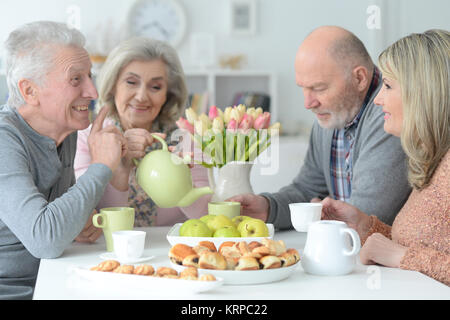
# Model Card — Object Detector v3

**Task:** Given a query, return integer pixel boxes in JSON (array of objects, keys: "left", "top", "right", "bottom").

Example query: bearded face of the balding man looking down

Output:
[{"left": 295, "top": 51, "right": 362, "bottom": 129}]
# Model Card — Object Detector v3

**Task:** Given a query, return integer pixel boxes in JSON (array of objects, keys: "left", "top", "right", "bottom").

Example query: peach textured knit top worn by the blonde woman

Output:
[{"left": 361, "top": 151, "right": 450, "bottom": 286}]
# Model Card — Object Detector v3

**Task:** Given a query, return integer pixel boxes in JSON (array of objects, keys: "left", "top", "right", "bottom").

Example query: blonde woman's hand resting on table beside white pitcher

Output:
[{"left": 359, "top": 233, "right": 408, "bottom": 268}]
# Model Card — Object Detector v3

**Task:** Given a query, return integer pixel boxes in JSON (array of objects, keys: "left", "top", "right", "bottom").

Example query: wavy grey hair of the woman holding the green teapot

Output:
[{"left": 96, "top": 37, "right": 188, "bottom": 127}]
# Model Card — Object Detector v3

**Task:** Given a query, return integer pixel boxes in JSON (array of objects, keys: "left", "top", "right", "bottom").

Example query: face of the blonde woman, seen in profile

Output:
[{"left": 374, "top": 77, "right": 403, "bottom": 137}]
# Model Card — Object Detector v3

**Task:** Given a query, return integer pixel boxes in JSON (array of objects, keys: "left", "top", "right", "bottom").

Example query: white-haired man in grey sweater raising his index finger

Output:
[{"left": 0, "top": 21, "right": 126, "bottom": 299}]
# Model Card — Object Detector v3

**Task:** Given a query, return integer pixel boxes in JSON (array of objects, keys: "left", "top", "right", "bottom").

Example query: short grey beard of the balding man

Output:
[{"left": 313, "top": 86, "right": 362, "bottom": 129}]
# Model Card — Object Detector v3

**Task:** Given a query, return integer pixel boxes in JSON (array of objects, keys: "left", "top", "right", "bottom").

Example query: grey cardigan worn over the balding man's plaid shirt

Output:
[{"left": 261, "top": 86, "right": 411, "bottom": 229}]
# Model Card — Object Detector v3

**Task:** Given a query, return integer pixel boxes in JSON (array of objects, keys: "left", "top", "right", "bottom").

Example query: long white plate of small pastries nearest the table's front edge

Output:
[{"left": 72, "top": 260, "right": 224, "bottom": 293}]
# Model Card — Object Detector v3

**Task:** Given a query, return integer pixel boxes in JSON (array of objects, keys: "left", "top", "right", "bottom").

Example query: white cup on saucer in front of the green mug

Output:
[{"left": 112, "top": 230, "right": 146, "bottom": 261}]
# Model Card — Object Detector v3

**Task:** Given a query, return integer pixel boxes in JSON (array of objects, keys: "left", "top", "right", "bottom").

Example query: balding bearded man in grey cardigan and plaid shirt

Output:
[{"left": 230, "top": 26, "right": 411, "bottom": 229}]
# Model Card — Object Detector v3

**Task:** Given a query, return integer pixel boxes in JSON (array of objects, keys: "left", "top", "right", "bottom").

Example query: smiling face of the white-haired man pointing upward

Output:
[{"left": 38, "top": 46, "right": 98, "bottom": 134}]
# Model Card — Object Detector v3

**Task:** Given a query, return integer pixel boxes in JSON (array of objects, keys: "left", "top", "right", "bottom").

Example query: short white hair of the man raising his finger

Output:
[{"left": 5, "top": 21, "right": 86, "bottom": 108}]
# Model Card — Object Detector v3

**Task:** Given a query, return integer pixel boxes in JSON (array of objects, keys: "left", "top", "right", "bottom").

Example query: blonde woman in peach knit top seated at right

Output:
[{"left": 322, "top": 30, "right": 450, "bottom": 285}]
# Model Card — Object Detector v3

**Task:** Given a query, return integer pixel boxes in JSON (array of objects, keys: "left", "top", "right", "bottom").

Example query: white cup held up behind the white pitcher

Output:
[{"left": 289, "top": 202, "right": 322, "bottom": 232}]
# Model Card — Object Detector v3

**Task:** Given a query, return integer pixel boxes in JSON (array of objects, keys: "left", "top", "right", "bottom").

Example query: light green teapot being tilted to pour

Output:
[{"left": 134, "top": 134, "right": 213, "bottom": 208}]
